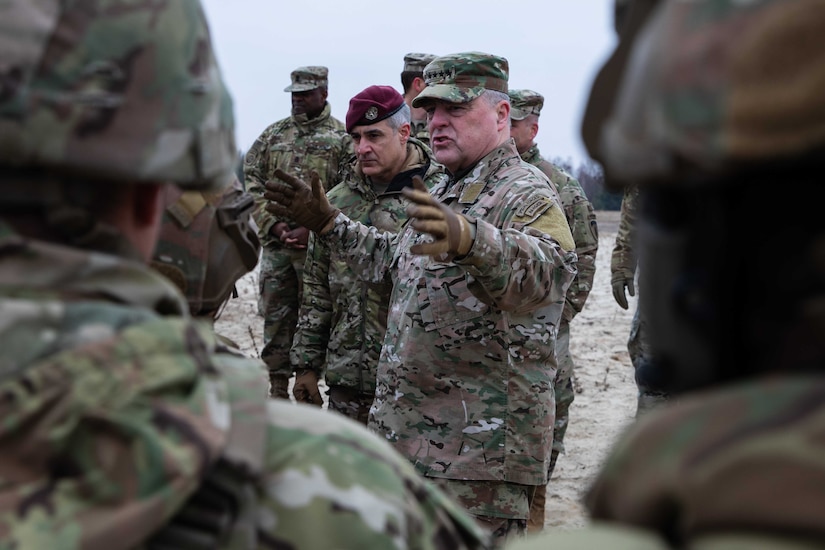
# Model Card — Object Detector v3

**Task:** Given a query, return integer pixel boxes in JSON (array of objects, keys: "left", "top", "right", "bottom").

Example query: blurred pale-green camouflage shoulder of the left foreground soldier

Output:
[{"left": 265, "top": 400, "right": 487, "bottom": 548}]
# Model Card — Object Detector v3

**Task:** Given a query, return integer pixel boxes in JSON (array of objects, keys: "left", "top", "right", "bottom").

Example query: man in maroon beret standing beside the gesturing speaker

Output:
[{"left": 290, "top": 86, "right": 447, "bottom": 425}]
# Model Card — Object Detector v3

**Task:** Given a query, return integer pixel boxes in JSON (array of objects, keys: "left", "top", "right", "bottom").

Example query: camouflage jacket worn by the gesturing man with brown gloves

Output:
[{"left": 323, "top": 143, "right": 576, "bottom": 485}]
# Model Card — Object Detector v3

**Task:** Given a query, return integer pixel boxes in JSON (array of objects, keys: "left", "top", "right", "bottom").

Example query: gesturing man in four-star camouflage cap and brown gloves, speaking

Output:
[{"left": 267, "top": 52, "right": 576, "bottom": 541}]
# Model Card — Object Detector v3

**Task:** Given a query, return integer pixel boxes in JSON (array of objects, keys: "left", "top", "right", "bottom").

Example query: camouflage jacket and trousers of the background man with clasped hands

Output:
[{"left": 244, "top": 103, "right": 353, "bottom": 380}]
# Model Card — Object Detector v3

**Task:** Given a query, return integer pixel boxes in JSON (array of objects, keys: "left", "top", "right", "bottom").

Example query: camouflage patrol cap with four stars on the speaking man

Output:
[{"left": 412, "top": 52, "right": 509, "bottom": 107}]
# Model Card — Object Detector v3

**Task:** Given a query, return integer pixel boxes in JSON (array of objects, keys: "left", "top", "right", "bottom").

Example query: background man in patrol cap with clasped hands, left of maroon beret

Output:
[{"left": 244, "top": 66, "right": 352, "bottom": 397}]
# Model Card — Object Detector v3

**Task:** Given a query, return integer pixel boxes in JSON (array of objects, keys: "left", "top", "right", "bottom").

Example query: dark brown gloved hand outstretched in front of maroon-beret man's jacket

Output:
[{"left": 264, "top": 168, "right": 340, "bottom": 234}]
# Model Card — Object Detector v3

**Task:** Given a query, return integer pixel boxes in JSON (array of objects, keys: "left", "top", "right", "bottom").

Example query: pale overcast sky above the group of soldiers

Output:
[{"left": 198, "top": 0, "right": 615, "bottom": 165}]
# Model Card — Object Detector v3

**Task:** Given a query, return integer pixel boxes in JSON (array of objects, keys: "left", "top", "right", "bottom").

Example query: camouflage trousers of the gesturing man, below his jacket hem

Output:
[{"left": 427, "top": 477, "right": 536, "bottom": 548}]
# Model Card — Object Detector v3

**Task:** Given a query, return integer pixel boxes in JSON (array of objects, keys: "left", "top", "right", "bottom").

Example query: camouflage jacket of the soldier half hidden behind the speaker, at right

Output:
[{"left": 521, "top": 145, "right": 599, "bottom": 323}]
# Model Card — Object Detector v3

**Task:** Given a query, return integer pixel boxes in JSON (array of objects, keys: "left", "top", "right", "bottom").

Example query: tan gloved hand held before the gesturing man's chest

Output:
[{"left": 402, "top": 176, "right": 473, "bottom": 258}]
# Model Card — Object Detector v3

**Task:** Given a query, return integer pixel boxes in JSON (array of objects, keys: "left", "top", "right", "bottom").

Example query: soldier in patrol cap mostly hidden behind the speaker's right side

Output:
[{"left": 509, "top": 90, "right": 599, "bottom": 531}]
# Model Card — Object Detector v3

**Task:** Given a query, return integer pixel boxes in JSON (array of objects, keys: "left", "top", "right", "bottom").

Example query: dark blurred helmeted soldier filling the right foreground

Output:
[{"left": 513, "top": 0, "right": 825, "bottom": 550}]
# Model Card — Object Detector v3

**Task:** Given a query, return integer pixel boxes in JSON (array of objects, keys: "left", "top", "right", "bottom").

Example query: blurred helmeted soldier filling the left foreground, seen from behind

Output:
[{"left": 0, "top": 0, "right": 490, "bottom": 549}]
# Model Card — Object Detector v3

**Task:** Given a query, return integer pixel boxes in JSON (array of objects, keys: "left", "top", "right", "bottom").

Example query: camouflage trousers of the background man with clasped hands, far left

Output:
[{"left": 258, "top": 247, "right": 306, "bottom": 397}]
